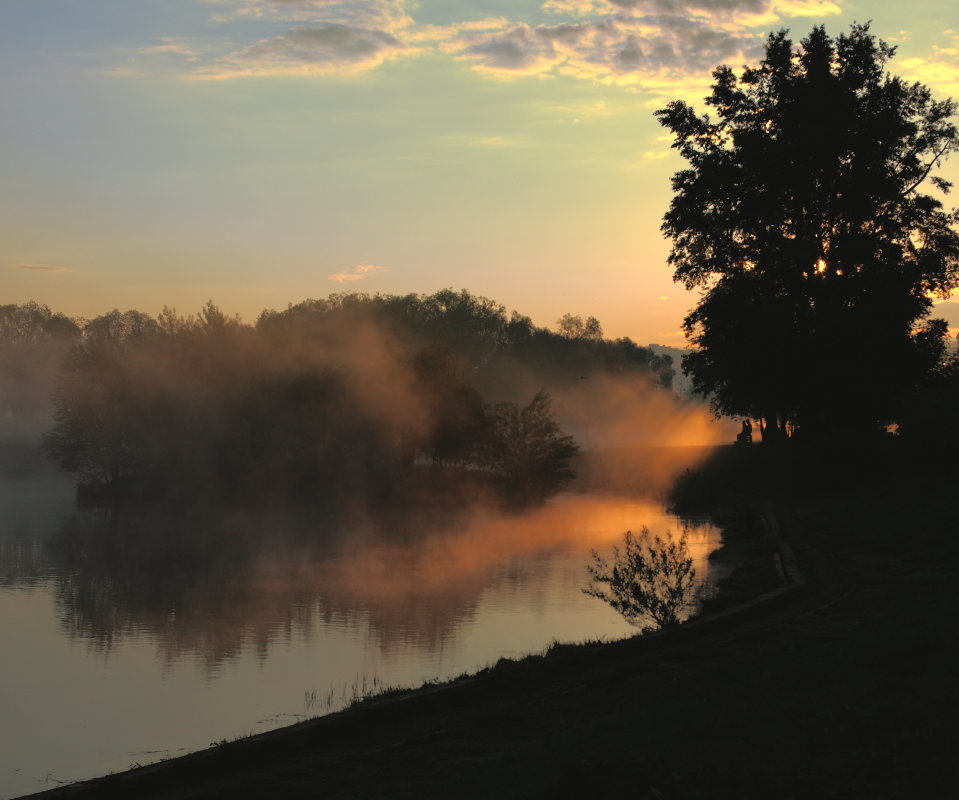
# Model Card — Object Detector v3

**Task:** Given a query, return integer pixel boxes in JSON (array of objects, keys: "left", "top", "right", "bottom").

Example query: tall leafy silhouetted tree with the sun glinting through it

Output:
[{"left": 657, "top": 25, "right": 959, "bottom": 439}]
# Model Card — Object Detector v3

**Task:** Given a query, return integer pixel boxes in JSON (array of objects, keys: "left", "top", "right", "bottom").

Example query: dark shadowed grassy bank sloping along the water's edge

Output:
[{"left": 24, "top": 447, "right": 959, "bottom": 800}]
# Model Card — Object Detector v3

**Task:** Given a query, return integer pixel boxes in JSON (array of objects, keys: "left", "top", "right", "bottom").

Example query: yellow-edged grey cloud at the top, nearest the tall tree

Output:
[{"left": 440, "top": 0, "right": 842, "bottom": 99}]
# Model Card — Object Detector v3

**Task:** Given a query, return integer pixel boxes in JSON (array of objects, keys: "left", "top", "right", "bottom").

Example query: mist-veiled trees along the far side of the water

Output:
[{"left": 0, "top": 290, "right": 673, "bottom": 505}]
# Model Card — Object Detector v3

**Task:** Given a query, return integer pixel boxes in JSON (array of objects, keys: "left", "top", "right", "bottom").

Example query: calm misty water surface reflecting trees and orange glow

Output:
[{"left": 0, "top": 468, "right": 718, "bottom": 798}]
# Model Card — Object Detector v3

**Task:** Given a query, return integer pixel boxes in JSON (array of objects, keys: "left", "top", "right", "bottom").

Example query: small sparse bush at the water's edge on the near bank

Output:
[{"left": 583, "top": 525, "right": 698, "bottom": 633}]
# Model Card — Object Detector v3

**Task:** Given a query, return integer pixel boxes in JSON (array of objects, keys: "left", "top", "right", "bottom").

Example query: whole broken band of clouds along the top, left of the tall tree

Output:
[{"left": 159, "top": 0, "right": 842, "bottom": 88}]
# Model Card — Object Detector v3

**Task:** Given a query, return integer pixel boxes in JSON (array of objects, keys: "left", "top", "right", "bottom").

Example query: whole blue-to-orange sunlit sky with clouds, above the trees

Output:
[{"left": 0, "top": 0, "right": 959, "bottom": 345}]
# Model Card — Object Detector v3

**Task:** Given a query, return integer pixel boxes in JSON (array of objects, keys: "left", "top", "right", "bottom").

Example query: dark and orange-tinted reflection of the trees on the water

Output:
[{"left": 0, "top": 495, "right": 715, "bottom": 670}]
